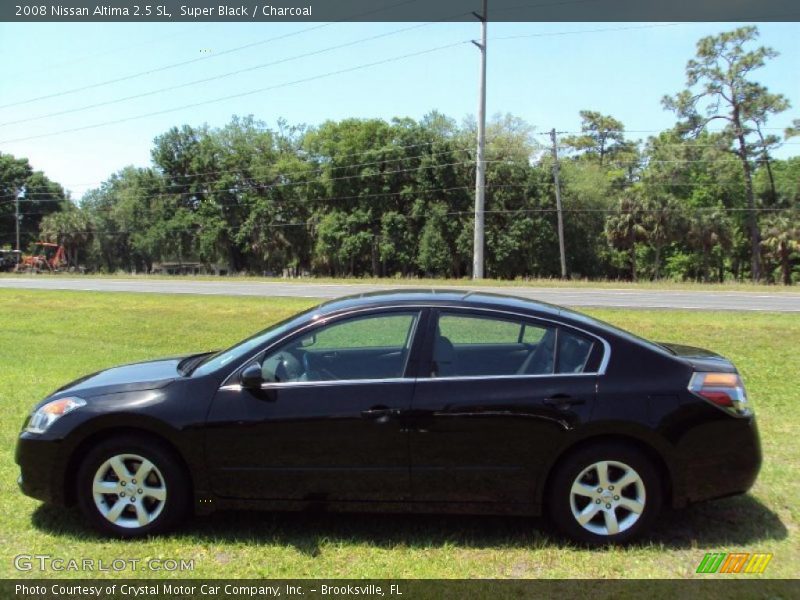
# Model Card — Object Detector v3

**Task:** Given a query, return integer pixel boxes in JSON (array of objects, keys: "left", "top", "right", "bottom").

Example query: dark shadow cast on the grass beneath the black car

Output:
[{"left": 32, "top": 495, "right": 788, "bottom": 557}]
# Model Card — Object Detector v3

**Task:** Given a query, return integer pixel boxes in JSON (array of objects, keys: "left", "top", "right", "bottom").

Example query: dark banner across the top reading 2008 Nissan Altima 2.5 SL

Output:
[{"left": 0, "top": 0, "right": 800, "bottom": 23}]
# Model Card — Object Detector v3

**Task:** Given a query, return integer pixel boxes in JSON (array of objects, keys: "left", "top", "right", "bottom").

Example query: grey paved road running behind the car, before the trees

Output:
[{"left": 0, "top": 276, "right": 800, "bottom": 312}]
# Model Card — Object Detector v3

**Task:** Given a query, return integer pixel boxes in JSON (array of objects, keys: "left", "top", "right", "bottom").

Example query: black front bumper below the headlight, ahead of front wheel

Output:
[{"left": 14, "top": 432, "right": 66, "bottom": 504}]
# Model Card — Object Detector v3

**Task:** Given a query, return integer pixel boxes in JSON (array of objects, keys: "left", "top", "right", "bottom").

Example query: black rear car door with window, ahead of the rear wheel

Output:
[{"left": 409, "top": 309, "right": 603, "bottom": 503}]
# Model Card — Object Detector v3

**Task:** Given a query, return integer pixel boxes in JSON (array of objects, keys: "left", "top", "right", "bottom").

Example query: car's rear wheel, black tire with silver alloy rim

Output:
[{"left": 547, "top": 442, "right": 663, "bottom": 546}]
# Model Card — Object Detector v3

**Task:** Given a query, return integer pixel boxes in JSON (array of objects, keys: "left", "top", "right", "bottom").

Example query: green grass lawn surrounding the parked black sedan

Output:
[{"left": 0, "top": 290, "right": 800, "bottom": 578}]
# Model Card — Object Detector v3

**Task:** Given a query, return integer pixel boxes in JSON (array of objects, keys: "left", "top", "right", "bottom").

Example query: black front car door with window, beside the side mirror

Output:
[{"left": 206, "top": 309, "right": 423, "bottom": 501}]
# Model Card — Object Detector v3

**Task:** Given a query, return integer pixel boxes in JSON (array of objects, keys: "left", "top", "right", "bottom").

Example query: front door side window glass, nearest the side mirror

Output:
[{"left": 261, "top": 312, "right": 419, "bottom": 383}]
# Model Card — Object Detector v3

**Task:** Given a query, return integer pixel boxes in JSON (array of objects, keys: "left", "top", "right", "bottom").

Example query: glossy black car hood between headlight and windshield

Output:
[{"left": 55, "top": 357, "right": 183, "bottom": 396}]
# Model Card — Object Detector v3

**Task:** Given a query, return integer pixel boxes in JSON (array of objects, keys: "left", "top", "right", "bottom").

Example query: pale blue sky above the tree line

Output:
[{"left": 0, "top": 23, "right": 800, "bottom": 199}]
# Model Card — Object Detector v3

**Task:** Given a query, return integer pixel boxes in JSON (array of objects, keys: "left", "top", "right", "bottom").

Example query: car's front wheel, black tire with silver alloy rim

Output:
[{"left": 76, "top": 434, "right": 191, "bottom": 538}]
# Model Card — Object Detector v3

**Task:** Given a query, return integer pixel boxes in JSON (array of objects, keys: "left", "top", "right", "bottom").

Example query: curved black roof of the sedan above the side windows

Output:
[{"left": 312, "top": 288, "right": 564, "bottom": 316}]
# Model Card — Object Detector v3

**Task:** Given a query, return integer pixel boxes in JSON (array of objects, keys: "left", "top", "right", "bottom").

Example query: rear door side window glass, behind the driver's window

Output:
[{"left": 431, "top": 312, "right": 594, "bottom": 377}]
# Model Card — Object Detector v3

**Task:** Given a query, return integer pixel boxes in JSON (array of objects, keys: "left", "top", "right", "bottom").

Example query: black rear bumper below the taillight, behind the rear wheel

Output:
[{"left": 674, "top": 417, "right": 762, "bottom": 506}]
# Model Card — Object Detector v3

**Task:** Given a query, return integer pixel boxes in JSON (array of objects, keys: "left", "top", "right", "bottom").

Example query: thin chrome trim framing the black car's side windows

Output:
[{"left": 219, "top": 304, "right": 611, "bottom": 390}]
